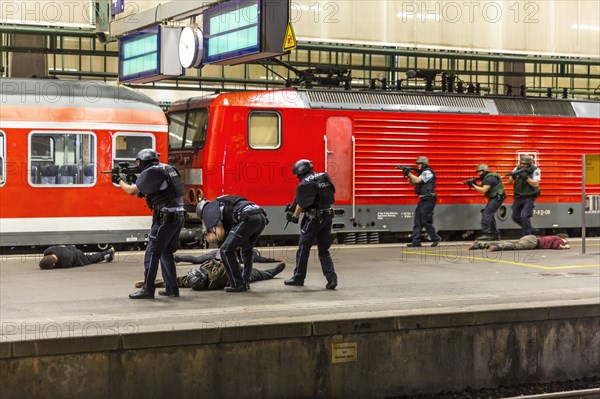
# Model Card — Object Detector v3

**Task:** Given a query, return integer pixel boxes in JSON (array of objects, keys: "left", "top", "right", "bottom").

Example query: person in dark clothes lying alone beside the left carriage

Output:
[{"left": 40, "top": 245, "right": 115, "bottom": 269}]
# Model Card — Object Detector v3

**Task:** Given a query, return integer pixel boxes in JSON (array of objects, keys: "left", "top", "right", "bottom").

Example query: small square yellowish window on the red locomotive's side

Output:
[{"left": 248, "top": 111, "right": 281, "bottom": 150}]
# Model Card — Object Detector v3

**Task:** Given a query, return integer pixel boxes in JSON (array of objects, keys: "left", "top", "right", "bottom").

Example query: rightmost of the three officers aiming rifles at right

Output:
[{"left": 508, "top": 155, "right": 542, "bottom": 236}]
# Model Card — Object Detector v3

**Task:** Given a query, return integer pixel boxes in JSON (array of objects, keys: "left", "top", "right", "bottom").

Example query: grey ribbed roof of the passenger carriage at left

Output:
[{"left": 0, "top": 78, "right": 158, "bottom": 108}]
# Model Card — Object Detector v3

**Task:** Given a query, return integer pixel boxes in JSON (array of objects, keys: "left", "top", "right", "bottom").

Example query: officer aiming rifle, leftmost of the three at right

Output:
[{"left": 406, "top": 156, "right": 442, "bottom": 247}]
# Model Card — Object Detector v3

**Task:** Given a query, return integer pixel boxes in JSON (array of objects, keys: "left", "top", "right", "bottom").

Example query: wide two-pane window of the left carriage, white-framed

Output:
[{"left": 29, "top": 132, "right": 96, "bottom": 187}]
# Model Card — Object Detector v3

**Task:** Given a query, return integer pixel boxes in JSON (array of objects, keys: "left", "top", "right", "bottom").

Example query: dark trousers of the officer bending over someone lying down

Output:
[{"left": 220, "top": 213, "right": 267, "bottom": 288}]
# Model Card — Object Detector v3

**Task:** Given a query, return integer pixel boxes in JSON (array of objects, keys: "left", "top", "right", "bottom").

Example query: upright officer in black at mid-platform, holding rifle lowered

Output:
[{"left": 284, "top": 159, "right": 337, "bottom": 290}]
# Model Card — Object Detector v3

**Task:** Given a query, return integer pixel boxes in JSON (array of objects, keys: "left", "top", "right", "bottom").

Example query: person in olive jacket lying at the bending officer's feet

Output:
[{"left": 135, "top": 257, "right": 285, "bottom": 291}]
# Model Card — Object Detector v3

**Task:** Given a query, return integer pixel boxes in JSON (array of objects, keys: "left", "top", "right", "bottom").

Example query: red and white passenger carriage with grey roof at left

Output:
[{"left": 0, "top": 79, "right": 168, "bottom": 247}]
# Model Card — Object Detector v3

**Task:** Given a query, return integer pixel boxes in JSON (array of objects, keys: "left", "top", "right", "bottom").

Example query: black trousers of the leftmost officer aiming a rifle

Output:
[{"left": 144, "top": 212, "right": 185, "bottom": 294}]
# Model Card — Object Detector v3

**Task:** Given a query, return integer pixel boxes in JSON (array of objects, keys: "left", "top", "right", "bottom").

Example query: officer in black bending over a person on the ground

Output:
[{"left": 196, "top": 195, "right": 268, "bottom": 292}]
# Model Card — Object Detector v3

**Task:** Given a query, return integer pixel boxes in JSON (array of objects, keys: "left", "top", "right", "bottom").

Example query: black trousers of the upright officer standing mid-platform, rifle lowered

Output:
[{"left": 293, "top": 213, "right": 337, "bottom": 282}]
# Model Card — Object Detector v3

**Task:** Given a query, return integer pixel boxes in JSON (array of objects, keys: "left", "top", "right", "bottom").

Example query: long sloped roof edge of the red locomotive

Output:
[{"left": 169, "top": 89, "right": 600, "bottom": 118}]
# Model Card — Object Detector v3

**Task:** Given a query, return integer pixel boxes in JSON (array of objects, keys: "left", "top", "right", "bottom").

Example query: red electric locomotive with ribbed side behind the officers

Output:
[{"left": 168, "top": 89, "right": 600, "bottom": 240}]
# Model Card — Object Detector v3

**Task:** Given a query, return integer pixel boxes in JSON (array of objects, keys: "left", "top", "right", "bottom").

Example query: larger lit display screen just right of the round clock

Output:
[{"left": 203, "top": 0, "right": 261, "bottom": 64}]
